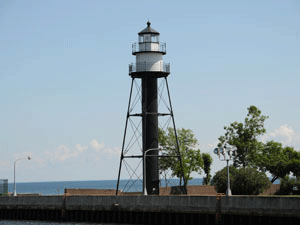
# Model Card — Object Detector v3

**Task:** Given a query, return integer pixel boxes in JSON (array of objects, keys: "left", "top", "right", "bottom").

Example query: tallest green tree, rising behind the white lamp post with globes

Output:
[{"left": 218, "top": 105, "right": 268, "bottom": 168}]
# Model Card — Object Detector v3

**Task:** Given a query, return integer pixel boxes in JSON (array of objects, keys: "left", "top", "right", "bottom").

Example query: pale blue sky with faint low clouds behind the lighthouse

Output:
[{"left": 0, "top": 0, "right": 300, "bottom": 182}]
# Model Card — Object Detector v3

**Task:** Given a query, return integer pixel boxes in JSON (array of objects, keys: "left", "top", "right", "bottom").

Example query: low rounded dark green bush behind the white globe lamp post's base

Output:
[{"left": 212, "top": 166, "right": 271, "bottom": 195}]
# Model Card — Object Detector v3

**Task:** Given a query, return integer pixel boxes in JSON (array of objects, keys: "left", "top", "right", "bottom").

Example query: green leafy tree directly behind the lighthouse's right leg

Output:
[{"left": 158, "top": 128, "right": 203, "bottom": 183}]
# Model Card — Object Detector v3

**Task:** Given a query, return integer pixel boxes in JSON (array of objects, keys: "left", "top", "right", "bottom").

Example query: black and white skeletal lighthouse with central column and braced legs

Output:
[{"left": 117, "top": 21, "right": 182, "bottom": 195}]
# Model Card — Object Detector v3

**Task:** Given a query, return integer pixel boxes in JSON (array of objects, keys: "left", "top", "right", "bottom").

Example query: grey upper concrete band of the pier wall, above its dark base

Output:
[{"left": 0, "top": 196, "right": 300, "bottom": 218}]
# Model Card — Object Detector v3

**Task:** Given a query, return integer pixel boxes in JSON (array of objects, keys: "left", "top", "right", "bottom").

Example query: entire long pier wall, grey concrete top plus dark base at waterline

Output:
[{"left": 0, "top": 196, "right": 300, "bottom": 224}]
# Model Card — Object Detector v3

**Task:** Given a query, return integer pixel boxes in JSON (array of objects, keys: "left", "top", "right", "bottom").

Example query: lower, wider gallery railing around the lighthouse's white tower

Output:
[{"left": 129, "top": 62, "right": 170, "bottom": 74}]
